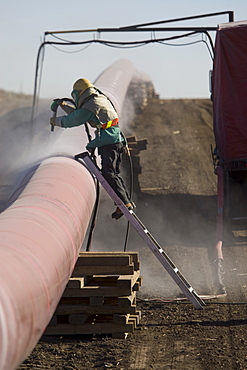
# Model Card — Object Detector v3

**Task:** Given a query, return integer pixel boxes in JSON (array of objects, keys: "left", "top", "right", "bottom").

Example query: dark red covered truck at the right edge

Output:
[{"left": 212, "top": 21, "right": 247, "bottom": 290}]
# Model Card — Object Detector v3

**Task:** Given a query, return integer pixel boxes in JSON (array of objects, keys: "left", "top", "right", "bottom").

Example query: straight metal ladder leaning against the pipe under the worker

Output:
[{"left": 75, "top": 152, "right": 206, "bottom": 309}]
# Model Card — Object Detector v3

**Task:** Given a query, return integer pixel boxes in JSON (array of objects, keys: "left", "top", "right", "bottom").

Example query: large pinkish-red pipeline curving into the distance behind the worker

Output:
[{"left": 0, "top": 60, "right": 141, "bottom": 370}]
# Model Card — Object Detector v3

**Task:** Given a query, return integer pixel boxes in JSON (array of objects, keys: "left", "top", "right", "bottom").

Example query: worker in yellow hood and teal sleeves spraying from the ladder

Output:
[{"left": 50, "top": 78, "right": 135, "bottom": 220}]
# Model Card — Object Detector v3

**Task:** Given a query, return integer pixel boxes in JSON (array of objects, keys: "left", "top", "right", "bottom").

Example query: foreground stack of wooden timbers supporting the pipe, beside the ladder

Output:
[{"left": 44, "top": 252, "right": 141, "bottom": 338}]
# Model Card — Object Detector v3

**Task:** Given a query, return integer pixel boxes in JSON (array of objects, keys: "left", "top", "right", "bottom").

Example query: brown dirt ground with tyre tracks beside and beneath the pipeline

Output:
[{"left": 1, "top": 90, "right": 247, "bottom": 370}]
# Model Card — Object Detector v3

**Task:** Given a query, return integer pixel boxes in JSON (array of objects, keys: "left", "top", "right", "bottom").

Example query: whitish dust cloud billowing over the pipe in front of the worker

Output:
[{"left": 0, "top": 101, "right": 87, "bottom": 211}]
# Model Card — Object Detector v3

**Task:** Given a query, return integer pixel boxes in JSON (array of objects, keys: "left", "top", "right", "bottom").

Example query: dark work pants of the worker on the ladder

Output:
[{"left": 98, "top": 143, "right": 131, "bottom": 204}]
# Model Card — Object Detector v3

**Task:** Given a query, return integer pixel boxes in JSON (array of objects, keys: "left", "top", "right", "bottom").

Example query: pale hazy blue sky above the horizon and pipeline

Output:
[{"left": 0, "top": 0, "right": 247, "bottom": 98}]
